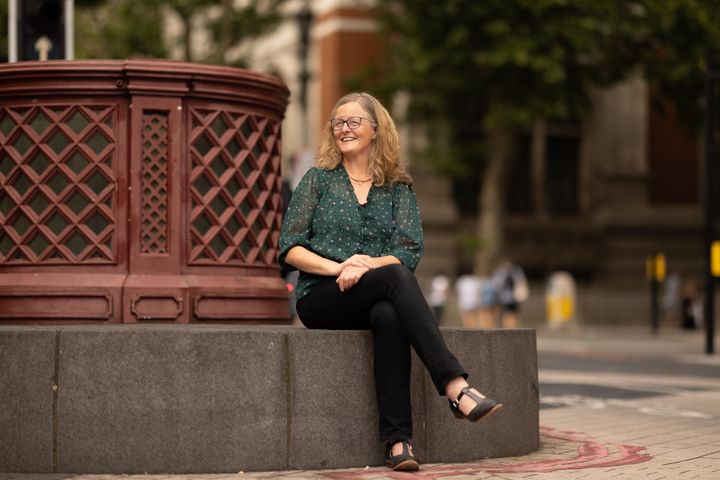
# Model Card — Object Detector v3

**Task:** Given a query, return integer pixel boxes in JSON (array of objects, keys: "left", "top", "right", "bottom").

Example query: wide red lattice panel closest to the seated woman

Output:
[{"left": 188, "top": 108, "right": 281, "bottom": 265}]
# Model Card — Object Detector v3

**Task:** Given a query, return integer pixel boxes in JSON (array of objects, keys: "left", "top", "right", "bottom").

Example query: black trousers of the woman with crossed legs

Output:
[{"left": 297, "top": 265, "right": 467, "bottom": 443}]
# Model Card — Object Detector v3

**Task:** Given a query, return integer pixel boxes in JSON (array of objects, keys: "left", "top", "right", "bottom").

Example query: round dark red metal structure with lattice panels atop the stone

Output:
[{"left": 0, "top": 60, "right": 289, "bottom": 323}]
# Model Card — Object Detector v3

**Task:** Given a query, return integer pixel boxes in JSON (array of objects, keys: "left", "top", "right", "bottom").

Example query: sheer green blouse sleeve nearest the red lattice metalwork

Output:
[{"left": 278, "top": 168, "right": 320, "bottom": 271}]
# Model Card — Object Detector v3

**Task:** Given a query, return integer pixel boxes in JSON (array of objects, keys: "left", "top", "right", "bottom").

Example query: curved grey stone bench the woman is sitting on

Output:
[{"left": 0, "top": 325, "right": 539, "bottom": 473}]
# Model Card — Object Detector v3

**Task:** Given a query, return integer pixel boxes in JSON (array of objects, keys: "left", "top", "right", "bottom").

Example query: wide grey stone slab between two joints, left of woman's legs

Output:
[{"left": 57, "top": 326, "right": 287, "bottom": 473}]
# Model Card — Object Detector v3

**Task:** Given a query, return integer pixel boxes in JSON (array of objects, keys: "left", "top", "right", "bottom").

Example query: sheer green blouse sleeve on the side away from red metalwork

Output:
[{"left": 383, "top": 183, "right": 424, "bottom": 272}]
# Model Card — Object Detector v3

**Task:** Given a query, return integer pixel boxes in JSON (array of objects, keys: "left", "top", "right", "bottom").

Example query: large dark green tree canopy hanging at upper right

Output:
[{"left": 379, "top": 0, "right": 720, "bottom": 200}]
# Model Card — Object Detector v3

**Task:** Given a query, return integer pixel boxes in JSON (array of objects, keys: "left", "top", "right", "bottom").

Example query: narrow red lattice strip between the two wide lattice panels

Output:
[{"left": 140, "top": 112, "right": 168, "bottom": 253}]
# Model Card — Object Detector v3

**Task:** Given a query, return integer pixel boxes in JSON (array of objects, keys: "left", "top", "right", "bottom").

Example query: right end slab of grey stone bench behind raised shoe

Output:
[{"left": 426, "top": 329, "right": 540, "bottom": 463}]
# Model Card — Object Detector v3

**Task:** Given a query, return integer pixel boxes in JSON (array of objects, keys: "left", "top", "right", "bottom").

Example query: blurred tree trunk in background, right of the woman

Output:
[{"left": 475, "top": 128, "right": 512, "bottom": 275}]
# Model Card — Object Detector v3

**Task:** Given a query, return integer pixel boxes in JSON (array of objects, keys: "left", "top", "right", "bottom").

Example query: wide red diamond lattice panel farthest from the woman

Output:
[{"left": 0, "top": 105, "right": 117, "bottom": 265}]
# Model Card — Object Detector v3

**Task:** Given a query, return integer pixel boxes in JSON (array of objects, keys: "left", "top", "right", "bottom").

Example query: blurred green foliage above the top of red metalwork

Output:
[{"left": 76, "top": 0, "right": 285, "bottom": 65}]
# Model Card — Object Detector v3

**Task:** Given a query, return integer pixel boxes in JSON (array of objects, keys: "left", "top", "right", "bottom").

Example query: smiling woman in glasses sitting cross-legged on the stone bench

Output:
[{"left": 278, "top": 93, "right": 502, "bottom": 470}]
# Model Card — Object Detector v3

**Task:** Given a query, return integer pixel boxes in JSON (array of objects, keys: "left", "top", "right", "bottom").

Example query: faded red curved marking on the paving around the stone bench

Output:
[{"left": 316, "top": 427, "right": 652, "bottom": 480}]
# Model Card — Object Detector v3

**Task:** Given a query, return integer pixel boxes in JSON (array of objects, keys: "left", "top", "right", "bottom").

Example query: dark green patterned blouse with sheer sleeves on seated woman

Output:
[{"left": 279, "top": 165, "right": 423, "bottom": 300}]
